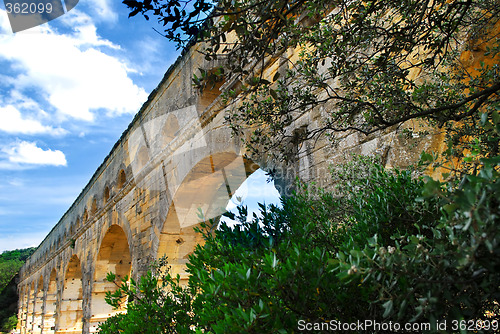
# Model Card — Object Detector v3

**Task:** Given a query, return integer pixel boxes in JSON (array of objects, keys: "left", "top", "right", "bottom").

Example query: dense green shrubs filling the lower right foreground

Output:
[{"left": 101, "top": 156, "right": 500, "bottom": 333}]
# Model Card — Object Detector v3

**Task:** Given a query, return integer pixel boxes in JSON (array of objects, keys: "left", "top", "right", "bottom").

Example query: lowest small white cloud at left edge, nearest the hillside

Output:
[{"left": 0, "top": 141, "right": 67, "bottom": 168}]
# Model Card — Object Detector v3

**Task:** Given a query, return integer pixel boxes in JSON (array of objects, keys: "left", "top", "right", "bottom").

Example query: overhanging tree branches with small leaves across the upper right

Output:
[{"left": 123, "top": 0, "right": 500, "bottom": 158}]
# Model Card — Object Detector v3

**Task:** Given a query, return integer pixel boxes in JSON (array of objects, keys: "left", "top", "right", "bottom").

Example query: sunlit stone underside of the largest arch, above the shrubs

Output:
[{"left": 157, "top": 152, "right": 259, "bottom": 283}]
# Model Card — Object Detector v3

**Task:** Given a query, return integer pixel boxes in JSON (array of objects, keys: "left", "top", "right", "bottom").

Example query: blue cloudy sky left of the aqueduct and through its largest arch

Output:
[{"left": 0, "top": 0, "right": 278, "bottom": 252}]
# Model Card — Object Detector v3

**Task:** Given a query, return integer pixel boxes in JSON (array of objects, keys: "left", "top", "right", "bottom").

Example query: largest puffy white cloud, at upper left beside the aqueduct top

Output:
[{"left": 0, "top": 8, "right": 147, "bottom": 121}]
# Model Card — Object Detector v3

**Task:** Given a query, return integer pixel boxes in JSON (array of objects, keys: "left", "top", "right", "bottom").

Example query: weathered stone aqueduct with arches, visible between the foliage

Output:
[{"left": 18, "top": 39, "right": 444, "bottom": 334}]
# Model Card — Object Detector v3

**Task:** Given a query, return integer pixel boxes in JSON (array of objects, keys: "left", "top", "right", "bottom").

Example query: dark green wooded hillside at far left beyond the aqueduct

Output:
[{"left": 0, "top": 247, "right": 36, "bottom": 333}]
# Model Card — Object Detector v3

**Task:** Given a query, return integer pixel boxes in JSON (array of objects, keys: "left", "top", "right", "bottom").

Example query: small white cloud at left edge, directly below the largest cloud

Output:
[{"left": 0, "top": 105, "right": 67, "bottom": 136}]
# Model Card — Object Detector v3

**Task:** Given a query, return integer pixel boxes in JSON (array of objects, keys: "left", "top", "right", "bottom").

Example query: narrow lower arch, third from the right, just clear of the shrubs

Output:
[{"left": 57, "top": 255, "right": 83, "bottom": 334}]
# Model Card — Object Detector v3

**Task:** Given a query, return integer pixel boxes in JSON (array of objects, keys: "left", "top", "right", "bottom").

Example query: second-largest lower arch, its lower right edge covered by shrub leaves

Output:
[{"left": 90, "top": 225, "right": 132, "bottom": 333}]
